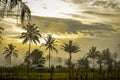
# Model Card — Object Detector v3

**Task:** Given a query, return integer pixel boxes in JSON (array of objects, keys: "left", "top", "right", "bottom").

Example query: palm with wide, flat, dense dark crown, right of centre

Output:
[{"left": 62, "top": 40, "right": 80, "bottom": 67}]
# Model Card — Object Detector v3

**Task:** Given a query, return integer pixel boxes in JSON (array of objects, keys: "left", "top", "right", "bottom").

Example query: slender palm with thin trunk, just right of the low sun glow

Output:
[{"left": 45, "top": 34, "right": 58, "bottom": 68}]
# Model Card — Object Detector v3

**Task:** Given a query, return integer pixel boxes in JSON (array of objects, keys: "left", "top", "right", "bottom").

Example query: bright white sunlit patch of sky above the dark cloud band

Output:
[{"left": 26, "top": 0, "right": 75, "bottom": 18}]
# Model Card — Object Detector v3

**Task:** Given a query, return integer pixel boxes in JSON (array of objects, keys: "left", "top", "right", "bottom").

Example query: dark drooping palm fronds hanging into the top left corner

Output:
[{"left": 0, "top": 0, "right": 31, "bottom": 24}]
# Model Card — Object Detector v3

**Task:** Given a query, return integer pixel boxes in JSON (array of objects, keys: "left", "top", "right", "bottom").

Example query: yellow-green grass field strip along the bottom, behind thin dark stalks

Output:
[{"left": 0, "top": 72, "right": 120, "bottom": 80}]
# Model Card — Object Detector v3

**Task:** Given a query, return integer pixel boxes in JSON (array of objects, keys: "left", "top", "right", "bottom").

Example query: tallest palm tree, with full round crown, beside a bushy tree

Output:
[{"left": 20, "top": 23, "right": 41, "bottom": 55}]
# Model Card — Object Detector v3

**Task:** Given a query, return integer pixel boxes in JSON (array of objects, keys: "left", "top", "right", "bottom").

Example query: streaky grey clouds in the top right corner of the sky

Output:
[{"left": 61, "top": 0, "right": 120, "bottom": 11}]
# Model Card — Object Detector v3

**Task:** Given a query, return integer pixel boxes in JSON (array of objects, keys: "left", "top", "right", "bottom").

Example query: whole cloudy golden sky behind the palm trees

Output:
[{"left": 0, "top": 0, "right": 120, "bottom": 65}]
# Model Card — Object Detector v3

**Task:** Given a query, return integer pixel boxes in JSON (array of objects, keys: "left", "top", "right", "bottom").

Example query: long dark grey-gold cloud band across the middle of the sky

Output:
[{"left": 30, "top": 16, "right": 117, "bottom": 37}]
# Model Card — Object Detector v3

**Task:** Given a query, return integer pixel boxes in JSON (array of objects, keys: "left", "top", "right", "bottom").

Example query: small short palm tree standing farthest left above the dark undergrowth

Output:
[{"left": 3, "top": 44, "right": 18, "bottom": 65}]
